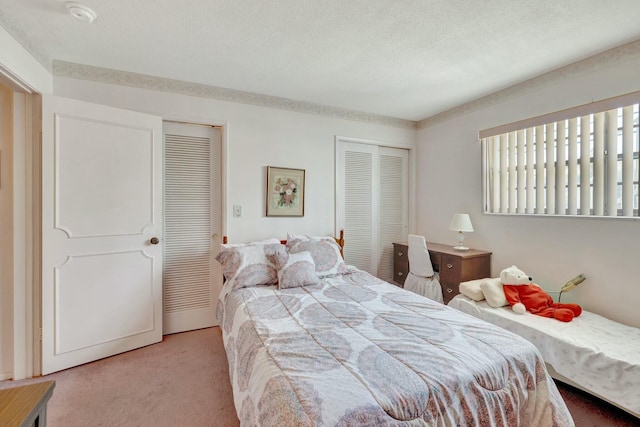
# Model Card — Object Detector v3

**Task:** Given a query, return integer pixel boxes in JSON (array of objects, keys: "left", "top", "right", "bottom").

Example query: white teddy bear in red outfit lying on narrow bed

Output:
[{"left": 500, "top": 265, "right": 582, "bottom": 322}]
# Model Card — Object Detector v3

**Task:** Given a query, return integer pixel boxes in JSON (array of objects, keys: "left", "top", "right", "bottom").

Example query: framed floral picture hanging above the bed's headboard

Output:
[{"left": 267, "top": 166, "right": 305, "bottom": 217}]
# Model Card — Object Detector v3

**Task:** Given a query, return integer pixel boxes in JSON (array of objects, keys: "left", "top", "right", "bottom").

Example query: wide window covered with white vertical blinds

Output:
[{"left": 479, "top": 92, "right": 640, "bottom": 217}]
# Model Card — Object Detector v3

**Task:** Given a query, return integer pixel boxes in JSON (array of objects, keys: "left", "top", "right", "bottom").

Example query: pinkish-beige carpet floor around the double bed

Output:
[{"left": 0, "top": 328, "right": 640, "bottom": 427}]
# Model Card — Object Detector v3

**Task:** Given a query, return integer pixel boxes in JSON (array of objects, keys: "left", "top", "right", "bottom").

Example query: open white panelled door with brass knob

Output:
[{"left": 42, "top": 96, "right": 163, "bottom": 374}]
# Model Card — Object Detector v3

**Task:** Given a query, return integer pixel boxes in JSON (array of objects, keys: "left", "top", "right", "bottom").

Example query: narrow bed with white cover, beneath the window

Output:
[{"left": 449, "top": 295, "right": 640, "bottom": 417}]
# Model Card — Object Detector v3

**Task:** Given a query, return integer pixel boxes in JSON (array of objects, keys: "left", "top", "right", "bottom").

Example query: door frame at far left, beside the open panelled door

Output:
[{"left": 0, "top": 77, "right": 41, "bottom": 380}]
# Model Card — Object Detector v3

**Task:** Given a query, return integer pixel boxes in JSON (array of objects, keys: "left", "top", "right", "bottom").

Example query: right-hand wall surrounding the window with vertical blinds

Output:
[{"left": 416, "top": 56, "right": 640, "bottom": 327}]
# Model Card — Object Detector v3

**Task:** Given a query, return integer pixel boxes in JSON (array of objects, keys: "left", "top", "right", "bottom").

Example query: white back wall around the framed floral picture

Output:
[{"left": 54, "top": 77, "right": 416, "bottom": 246}]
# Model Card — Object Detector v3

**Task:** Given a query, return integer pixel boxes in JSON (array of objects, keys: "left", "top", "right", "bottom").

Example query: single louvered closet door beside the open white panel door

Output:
[{"left": 163, "top": 122, "right": 222, "bottom": 334}]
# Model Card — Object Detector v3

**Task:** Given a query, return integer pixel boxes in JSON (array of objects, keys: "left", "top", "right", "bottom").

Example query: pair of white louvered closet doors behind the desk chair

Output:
[{"left": 336, "top": 139, "right": 409, "bottom": 281}]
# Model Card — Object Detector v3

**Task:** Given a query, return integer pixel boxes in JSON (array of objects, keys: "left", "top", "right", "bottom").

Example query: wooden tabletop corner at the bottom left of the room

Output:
[{"left": 0, "top": 381, "right": 56, "bottom": 427}]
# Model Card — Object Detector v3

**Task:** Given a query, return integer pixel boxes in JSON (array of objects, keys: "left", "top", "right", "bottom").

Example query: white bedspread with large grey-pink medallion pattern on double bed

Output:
[{"left": 218, "top": 270, "right": 574, "bottom": 427}]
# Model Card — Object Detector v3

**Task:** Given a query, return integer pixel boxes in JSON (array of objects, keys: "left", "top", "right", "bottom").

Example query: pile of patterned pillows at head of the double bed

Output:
[{"left": 216, "top": 234, "right": 347, "bottom": 289}]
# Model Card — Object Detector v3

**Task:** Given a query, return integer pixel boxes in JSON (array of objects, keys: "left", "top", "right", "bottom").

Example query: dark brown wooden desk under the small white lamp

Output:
[{"left": 393, "top": 242, "right": 491, "bottom": 304}]
